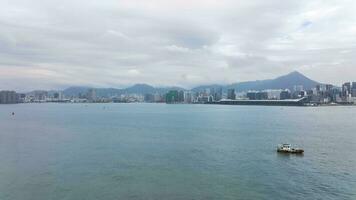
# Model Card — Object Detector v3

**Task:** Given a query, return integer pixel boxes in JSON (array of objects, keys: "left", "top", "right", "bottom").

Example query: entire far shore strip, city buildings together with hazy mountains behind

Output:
[{"left": 0, "top": 71, "right": 356, "bottom": 106}]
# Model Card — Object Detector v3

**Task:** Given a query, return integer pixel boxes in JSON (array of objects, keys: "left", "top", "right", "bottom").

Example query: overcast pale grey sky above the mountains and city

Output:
[{"left": 0, "top": 0, "right": 356, "bottom": 91}]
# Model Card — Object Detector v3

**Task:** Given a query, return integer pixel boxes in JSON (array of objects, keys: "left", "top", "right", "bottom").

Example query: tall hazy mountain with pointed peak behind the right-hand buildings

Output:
[{"left": 193, "top": 71, "right": 320, "bottom": 92}]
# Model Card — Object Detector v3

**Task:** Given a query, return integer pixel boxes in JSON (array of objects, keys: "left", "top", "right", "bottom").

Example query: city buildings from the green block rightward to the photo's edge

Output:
[{"left": 166, "top": 82, "right": 356, "bottom": 105}]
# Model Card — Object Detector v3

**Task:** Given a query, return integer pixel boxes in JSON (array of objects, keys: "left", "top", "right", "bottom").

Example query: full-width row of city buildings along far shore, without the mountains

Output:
[{"left": 0, "top": 82, "right": 356, "bottom": 105}]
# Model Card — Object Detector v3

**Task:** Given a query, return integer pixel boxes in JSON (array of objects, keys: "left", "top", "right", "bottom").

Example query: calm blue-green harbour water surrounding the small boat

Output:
[{"left": 0, "top": 104, "right": 356, "bottom": 200}]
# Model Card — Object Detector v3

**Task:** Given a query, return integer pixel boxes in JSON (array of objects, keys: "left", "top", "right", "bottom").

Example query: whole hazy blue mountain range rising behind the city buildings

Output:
[{"left": 63, "top": 71, "right": 320, "bottom": 97}]
